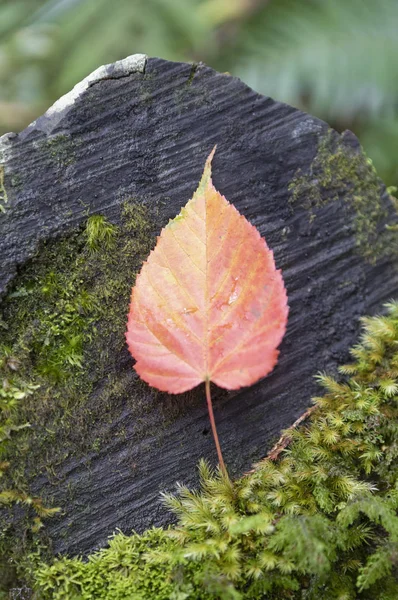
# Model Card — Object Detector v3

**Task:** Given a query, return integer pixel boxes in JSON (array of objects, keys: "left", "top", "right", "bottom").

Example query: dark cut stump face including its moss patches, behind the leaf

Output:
[{"left": 0, "top": 55, "right": 398, "bottom": 554}]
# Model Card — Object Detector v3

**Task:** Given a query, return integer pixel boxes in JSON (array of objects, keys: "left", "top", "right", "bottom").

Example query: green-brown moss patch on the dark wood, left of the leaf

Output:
[{"left": 0, "top": 202, "right": 154, "bottom": 588}]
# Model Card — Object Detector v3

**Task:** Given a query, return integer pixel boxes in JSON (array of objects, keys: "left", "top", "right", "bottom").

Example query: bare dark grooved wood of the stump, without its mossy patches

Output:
[{"left": 0, "top": 59, "right": 398, "bottom": 553}]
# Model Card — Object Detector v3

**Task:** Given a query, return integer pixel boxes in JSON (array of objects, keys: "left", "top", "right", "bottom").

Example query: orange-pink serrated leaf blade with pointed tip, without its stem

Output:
[{"left": 126, "top": 149, "right": 288, "bottom": 394}]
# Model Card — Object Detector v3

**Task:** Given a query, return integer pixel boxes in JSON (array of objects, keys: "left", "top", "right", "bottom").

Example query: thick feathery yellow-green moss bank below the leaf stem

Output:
[{"left": 32, "top": 303, "right": 398, "bottom": 600}]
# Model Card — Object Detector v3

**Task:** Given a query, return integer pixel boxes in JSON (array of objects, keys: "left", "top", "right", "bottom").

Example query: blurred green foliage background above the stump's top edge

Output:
[{"left": 0, "top": 0, "right": 398, "bottom": 185}]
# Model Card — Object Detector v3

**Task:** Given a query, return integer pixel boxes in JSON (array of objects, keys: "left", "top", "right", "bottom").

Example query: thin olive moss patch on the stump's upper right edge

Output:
[{"left": 289, "top": 130, "right": 398, "bottom": 263}]
